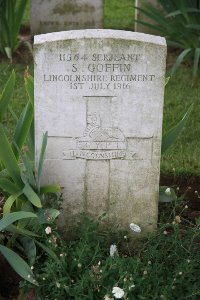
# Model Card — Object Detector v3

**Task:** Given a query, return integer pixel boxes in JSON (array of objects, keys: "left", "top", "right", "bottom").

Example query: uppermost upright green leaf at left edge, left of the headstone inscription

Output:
[{"left": 0, "top": 70, "right": 15, "bottom": 121}]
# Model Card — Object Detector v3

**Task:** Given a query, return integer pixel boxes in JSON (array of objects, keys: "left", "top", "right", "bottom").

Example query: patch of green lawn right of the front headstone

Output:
[{"left": 161, "top": 67, "right": 200, "bottom": 176}]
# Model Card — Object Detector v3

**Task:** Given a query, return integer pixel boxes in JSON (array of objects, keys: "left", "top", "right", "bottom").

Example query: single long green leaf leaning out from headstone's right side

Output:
[{"left": 161, "top": 104, "right": 193, "bottom": 154}]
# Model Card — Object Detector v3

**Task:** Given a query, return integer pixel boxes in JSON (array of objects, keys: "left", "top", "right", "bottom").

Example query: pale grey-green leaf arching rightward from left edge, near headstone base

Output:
[{"left": 0, "top": 211, "right": 37, "bottom": 231}]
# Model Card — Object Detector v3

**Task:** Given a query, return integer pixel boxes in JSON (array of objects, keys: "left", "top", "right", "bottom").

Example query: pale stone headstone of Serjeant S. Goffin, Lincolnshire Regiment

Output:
[{"left": 34, "top": 30, "right": 166, "bottom": 231}]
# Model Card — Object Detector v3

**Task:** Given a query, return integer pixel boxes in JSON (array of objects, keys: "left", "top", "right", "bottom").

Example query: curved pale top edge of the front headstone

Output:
[{"left": 34, "top": 29, "right": 166, "bottom": 46}]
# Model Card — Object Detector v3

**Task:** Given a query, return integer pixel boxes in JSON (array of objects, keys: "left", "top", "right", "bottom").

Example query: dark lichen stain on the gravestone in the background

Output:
[{"left": 53, "top": 2, "right": 95, "bottom": 15}]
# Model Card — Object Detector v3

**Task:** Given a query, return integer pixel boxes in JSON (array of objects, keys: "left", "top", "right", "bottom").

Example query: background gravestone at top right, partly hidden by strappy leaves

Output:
[{"left": 135, "top": 0, "right": 162, "bottom": 34}]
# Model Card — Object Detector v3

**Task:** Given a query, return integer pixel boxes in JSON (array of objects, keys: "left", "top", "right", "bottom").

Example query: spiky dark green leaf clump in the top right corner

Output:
[{"left": 137, "top": 0, "right": 200, "bottom": 76}]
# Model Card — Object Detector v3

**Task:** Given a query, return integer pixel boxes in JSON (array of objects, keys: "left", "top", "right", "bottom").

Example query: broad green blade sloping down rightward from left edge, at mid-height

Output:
[{"left": 0, "top": 124, "right": 24, "bottom": 188}]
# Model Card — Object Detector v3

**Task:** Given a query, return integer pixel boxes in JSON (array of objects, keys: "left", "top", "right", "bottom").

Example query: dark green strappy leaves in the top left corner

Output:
[{"left": 0, "top": 0, "right": 27, "bottom": 59}]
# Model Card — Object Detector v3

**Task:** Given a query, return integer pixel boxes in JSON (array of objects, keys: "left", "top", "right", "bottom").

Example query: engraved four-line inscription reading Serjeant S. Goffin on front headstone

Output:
[{"left": 43, "top": 50, "right": 157, "bottom": 91}]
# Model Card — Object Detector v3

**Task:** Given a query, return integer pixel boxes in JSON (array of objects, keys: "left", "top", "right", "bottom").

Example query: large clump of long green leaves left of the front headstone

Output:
[{"left": 0, "top": 72, "right": 60, "bottom": 284}]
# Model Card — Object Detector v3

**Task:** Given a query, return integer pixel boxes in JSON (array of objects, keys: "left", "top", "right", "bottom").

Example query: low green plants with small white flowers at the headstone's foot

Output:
[{"left": 21, "top": 211, "right": 200, "bottom": 300}]
